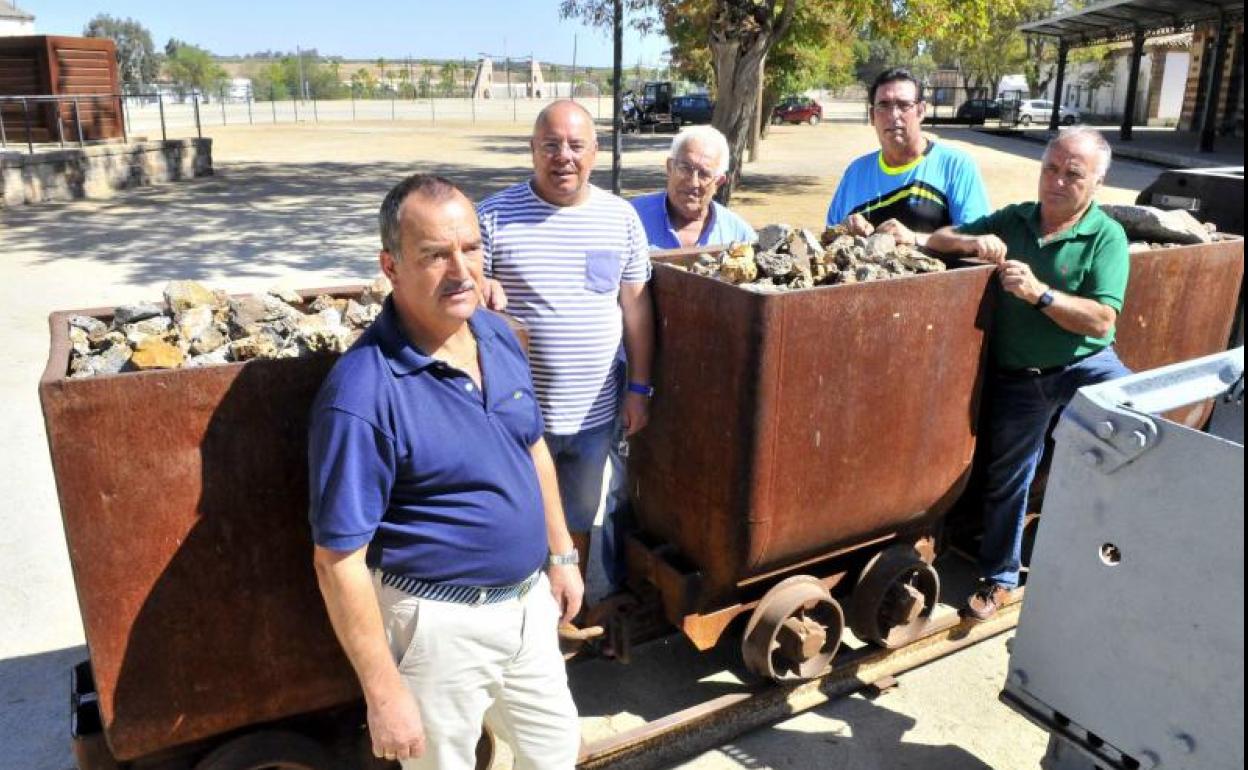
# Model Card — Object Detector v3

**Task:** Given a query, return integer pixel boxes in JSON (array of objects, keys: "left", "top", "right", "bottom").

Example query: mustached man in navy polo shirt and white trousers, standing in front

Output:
[{"left": 308, "top": 175, "right": 584, "bottom": 770}]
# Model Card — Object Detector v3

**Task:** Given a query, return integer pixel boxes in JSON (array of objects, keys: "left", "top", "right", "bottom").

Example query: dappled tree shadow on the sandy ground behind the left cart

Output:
[{"left": 2, "top": 162, "right": 528, "bottom": 283}]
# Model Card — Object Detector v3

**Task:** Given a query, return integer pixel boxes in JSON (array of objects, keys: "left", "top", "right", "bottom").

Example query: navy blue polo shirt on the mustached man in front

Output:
[{"left": 308, "top": 301, "right": 547, "bottom": 587}]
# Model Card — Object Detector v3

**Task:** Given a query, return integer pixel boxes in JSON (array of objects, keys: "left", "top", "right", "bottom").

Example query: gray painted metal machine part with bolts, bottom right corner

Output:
[{"left": 1001, "top": 347, "right": 1244, "bottom": 770}]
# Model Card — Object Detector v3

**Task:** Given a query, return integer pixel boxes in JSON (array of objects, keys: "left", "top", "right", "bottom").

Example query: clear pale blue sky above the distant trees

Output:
[{"left": 26, "top": 0, "right": 668, "bottom": 66}]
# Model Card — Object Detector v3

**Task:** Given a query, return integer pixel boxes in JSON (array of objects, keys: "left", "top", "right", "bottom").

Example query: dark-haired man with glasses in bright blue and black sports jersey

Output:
[{"left": 827, "top": 67, "right": 990, "bottom": 246}]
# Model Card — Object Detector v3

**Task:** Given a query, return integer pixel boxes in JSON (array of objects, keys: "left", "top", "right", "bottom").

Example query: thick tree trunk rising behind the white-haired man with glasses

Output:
[{"left": 710, "top": 0, "right": 796, "bottom": 205}]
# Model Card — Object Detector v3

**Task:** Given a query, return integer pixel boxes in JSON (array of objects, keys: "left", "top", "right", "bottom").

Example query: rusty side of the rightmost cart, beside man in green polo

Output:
[{"left": 1114, "top": 237, "right": 1244, "bottom": 428}]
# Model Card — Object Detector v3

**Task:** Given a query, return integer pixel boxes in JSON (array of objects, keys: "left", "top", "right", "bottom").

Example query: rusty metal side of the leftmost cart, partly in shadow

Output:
[{"left": 39, "top": 290, "right": 369, "bottom": 760}]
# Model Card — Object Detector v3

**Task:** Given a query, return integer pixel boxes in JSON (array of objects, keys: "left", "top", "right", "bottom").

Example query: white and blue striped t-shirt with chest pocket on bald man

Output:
[{"left": 478, "top": 182, "right": 650, "bottom": 436}]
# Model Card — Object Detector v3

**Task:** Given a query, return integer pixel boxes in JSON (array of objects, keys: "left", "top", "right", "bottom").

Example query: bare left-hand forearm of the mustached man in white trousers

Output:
[{"left": 316, "top": 548, "right": 406, "bottom": 704}]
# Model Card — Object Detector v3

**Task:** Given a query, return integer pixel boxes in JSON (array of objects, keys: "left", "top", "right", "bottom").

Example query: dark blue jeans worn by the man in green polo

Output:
[{"left": 980, "top": 347, "right": 1131, "bottom": 588}]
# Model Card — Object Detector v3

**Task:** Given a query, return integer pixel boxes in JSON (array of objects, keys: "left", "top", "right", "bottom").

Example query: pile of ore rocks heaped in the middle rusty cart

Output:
[{"left": 689, "top": 225, "right": 945, "bottom": 293}]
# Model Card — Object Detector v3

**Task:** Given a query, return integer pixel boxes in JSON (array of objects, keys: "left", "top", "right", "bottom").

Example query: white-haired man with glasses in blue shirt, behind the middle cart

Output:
[{"left": 630, "top": 126, "right": 758, "bottom": 248}]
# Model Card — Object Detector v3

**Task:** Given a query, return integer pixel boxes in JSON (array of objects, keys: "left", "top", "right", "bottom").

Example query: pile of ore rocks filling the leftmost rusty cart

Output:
[{"left": 69, "top": 276, "right": 391, "bottom": 378}]
